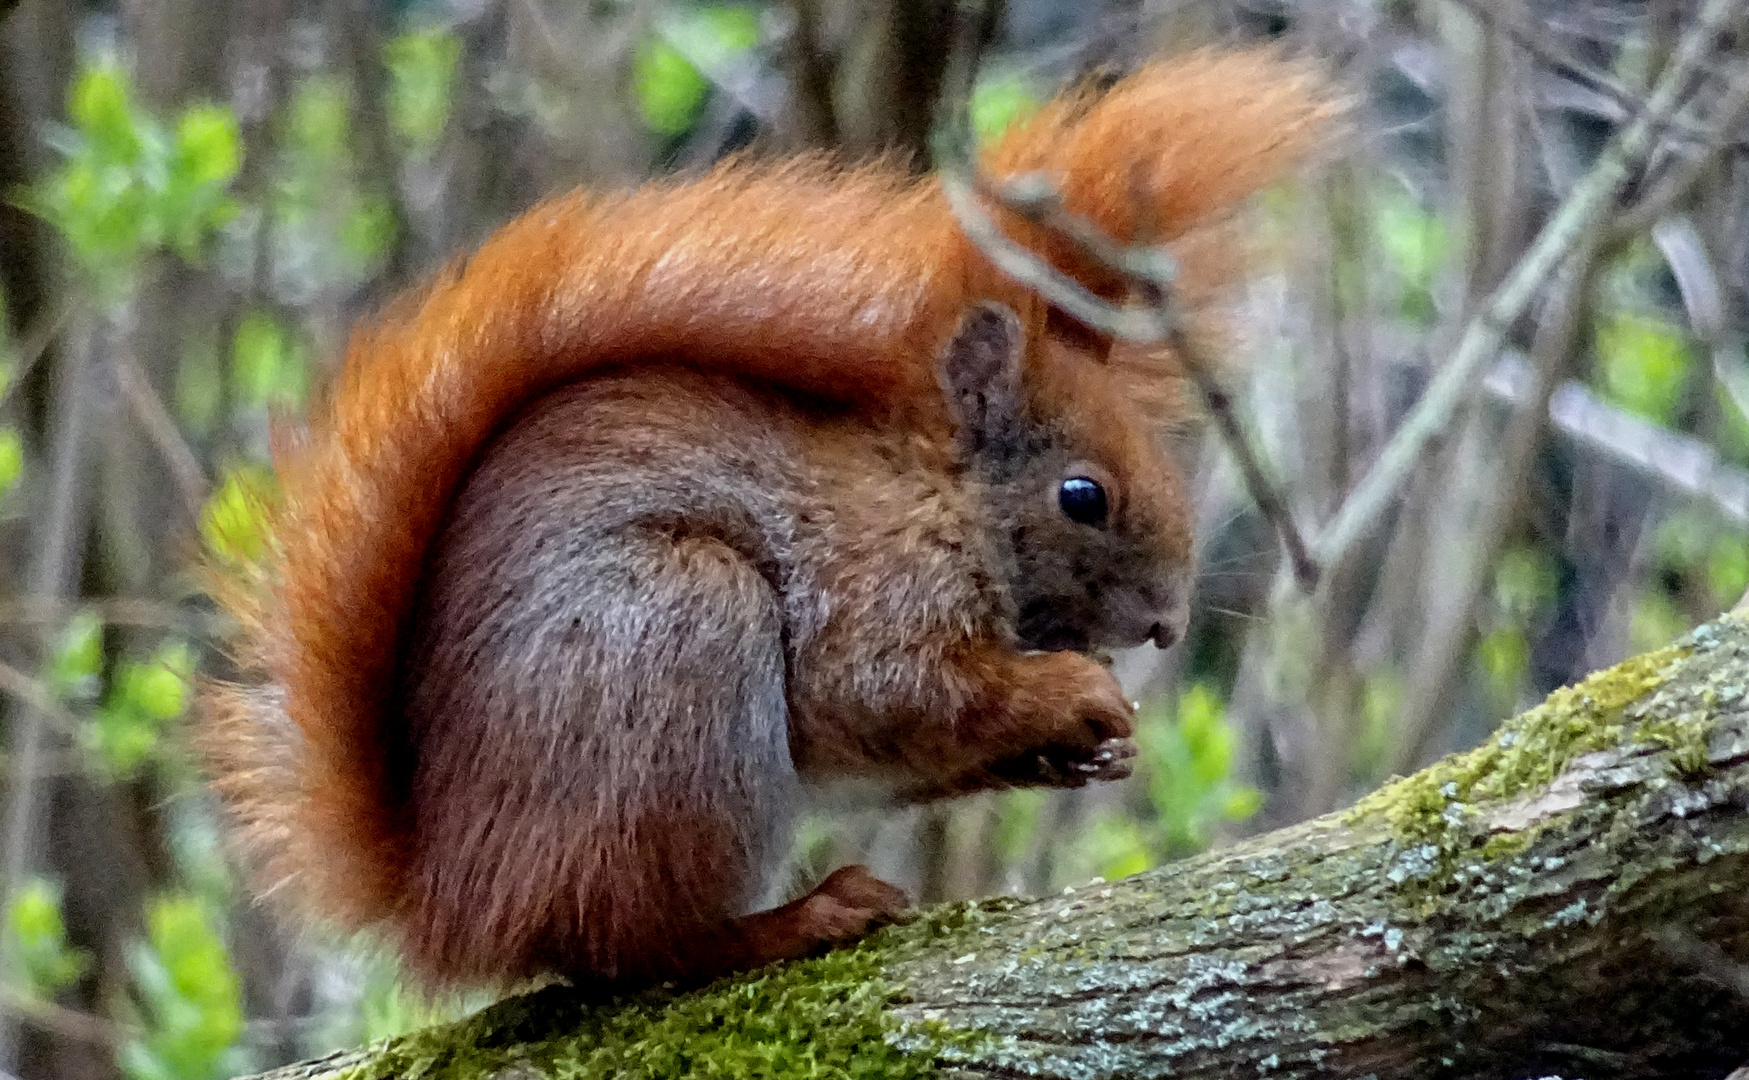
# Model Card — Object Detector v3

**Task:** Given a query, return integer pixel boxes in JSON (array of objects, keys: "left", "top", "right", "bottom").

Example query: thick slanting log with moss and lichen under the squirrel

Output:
[{"left": 243, "top": 616, "right": 1749, "bottom": 1080}]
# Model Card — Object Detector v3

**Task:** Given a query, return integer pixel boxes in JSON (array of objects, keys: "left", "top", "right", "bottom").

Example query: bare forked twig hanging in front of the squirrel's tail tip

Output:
[{"left": 934, "top": 11, "right": 1319, "bottom": 590}]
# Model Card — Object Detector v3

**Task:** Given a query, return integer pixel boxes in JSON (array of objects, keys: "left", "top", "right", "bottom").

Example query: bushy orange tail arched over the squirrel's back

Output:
[{"left": 201, "top": 53, "right": 1331, "bottom": 928}]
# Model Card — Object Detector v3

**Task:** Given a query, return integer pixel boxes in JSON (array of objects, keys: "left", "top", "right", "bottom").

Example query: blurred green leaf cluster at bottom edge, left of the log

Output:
[{"left": 119, "top": 896, "right": 248, "bottom": 1080}]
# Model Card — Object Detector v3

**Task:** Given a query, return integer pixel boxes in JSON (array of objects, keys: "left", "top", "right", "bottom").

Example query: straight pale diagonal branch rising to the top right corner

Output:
[{"left": 1313, "top": 0, "right": 1739, "bottom": 567}]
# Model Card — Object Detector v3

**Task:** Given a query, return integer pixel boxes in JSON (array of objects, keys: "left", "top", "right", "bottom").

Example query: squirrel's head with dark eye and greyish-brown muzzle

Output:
[{"left": 937, "top": 303, "right": 1191, "bottom": 651}]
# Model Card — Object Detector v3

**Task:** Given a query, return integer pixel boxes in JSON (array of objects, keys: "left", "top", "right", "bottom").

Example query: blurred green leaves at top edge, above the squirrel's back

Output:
[{"left": 631, "top": 4, "right": 759, "bottom": 135}]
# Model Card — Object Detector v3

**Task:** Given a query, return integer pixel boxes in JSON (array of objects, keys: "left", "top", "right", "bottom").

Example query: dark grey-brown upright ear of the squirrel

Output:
[{"left": 936, "top": 303, "right": 1027, "bottom": 450}]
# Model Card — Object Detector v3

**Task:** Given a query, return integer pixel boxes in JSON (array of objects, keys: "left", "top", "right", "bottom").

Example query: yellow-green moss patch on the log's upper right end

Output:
[{"left": 1348, "top": 646, "right": 1705, "bottom": 844}]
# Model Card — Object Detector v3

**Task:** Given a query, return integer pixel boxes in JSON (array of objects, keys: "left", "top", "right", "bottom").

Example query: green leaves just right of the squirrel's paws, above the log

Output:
[{"left": 1137, "top": 683, "right": 1263, "bottom": 858}]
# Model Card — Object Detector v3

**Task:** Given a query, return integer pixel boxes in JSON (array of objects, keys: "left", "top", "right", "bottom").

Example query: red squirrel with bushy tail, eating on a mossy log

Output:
[{"left": 198, "top": 51, "right": 1333, "bottom": 987}]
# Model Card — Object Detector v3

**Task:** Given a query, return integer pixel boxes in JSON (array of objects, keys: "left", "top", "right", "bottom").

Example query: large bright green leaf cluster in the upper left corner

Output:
[{"left": 21, "top": 63, "right": 243, "bottom": 301}]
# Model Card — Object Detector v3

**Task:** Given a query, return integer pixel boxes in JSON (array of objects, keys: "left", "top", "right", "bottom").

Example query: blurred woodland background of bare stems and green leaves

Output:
[{"left": 0, "top": 0, "right": 1749, "bottom": 1080}]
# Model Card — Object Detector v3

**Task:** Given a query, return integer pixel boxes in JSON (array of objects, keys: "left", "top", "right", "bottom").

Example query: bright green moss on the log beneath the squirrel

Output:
[{"left": 332, "top": 907, "right": 983, "bottom": 1080}]
